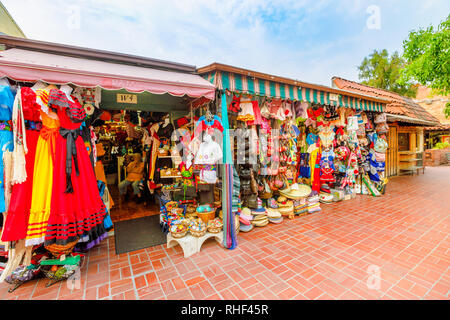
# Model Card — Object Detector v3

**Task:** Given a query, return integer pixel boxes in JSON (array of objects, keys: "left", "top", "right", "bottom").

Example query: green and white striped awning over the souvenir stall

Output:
[{"left": 202, "top": 71, "right": 383, "bottom": 112}]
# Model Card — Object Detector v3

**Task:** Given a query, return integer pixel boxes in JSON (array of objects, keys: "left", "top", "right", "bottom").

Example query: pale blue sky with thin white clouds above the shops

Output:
[{"left": 2, "top": 0, "right": 450, "bottom": 85}]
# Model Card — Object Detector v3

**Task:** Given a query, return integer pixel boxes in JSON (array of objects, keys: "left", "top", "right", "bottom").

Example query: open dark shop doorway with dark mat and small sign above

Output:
[{"left": 93, "top": 90, "right": 201, "bottom": 254}]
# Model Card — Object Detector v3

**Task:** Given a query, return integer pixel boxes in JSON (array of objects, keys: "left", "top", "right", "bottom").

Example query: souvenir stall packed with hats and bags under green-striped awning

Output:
[{"left": 199, "top": 64, "right": 388, "bottom": 232}]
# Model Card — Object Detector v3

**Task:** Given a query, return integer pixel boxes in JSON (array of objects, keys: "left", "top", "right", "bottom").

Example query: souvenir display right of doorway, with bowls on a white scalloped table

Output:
[{"left": 160, "top": 92, "right": 239, "bottom": 257}]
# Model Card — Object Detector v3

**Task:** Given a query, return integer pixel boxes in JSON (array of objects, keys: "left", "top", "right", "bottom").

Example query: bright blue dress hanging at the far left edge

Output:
[{"left": 0, "top": 86, "right": 14, "bottom": 212}]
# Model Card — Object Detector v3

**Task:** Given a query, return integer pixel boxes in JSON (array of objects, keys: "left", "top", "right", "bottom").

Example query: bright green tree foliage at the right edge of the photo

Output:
[{"left": 400, "top": 15, "right": 450, "bottom": 95}]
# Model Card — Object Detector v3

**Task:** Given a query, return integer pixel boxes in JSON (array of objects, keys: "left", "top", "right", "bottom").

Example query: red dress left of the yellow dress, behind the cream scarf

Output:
[{"left": 2, "top": 87, "right": 42, "bottom": 241}]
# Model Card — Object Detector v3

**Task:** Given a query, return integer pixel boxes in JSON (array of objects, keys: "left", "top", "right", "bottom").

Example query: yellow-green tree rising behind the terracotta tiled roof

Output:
[{"left": 358, "top": 49, "right": 417, "bottom": 97}]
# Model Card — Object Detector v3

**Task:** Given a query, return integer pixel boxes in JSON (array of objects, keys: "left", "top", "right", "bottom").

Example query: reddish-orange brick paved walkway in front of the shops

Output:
[{"left": 0, "top": 167, "right": 450, "bottom": 299}]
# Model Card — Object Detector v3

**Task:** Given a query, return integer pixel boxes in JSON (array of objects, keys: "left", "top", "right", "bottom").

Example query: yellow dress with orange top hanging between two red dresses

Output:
[{"left": 25, "top": 111, "right": 60, "bottom": 246}]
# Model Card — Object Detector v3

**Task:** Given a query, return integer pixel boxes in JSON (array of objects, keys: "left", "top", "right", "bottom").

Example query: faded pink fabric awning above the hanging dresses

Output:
[{"left": 0, "top": 48, "right": 215, "bottom": 100}]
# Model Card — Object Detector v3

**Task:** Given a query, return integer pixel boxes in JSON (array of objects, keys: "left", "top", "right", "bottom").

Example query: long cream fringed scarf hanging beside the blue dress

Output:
[{"left": 11, "top": 89, "right": 28, "bottom": 185}]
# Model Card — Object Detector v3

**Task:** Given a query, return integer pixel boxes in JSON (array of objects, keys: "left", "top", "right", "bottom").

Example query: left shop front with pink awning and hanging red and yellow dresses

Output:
[{"left": 0, "top": 36, "right": 215, "bottom": 292}]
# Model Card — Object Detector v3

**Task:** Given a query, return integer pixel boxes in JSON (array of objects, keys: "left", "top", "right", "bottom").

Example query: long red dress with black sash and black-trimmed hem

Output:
[{"left": 44, "top": 102, "right": 106, "bottom": 245}]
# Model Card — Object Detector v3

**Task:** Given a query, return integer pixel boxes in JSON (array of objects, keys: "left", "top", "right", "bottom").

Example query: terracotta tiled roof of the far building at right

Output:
[{"left": 332, "top": 77, "right": 440, "bottom": 125}]
